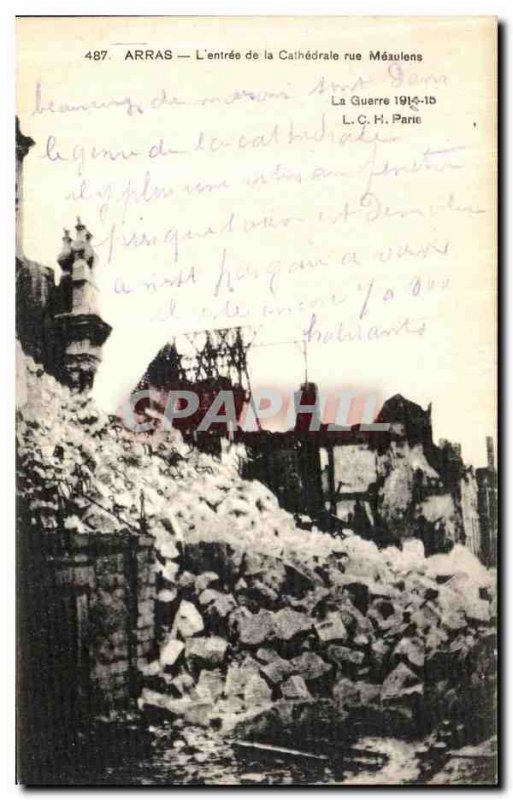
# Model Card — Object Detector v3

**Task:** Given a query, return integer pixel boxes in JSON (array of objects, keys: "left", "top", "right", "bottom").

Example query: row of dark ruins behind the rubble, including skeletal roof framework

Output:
[{"left": 136, "top": 329, "right": 496, "bottom": 564}]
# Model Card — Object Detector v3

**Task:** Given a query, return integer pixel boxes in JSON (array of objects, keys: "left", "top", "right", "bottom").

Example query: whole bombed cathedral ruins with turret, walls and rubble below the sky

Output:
[{"left": 16, "top": 115, "right": 497, "bottom": 786}]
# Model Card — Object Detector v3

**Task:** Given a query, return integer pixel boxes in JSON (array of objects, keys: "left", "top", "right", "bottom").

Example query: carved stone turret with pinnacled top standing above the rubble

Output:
[{"left": 51, "top": 218, "right": 112, "bottom": 392}]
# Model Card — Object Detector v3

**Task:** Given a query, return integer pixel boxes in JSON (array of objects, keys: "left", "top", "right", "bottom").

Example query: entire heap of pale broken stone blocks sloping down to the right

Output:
[{"left": 18, "top": 352, "right": 496, "bottom": 749}]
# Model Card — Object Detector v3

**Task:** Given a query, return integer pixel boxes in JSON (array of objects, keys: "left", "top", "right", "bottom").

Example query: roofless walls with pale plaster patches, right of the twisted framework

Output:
[{"left": 245, "top": 387, "right": 490, "bottom": 555}]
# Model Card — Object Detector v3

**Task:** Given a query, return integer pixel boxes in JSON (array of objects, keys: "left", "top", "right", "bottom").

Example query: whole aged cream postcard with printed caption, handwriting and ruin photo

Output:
[{"left": 16, "top": 16, "right": 497, "bottom": 784}]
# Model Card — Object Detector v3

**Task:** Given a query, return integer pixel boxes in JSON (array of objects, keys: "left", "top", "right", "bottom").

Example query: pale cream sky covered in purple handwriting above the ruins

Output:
[{"left": 17, "top": 18, "right": 496, "bottom": 466}]
